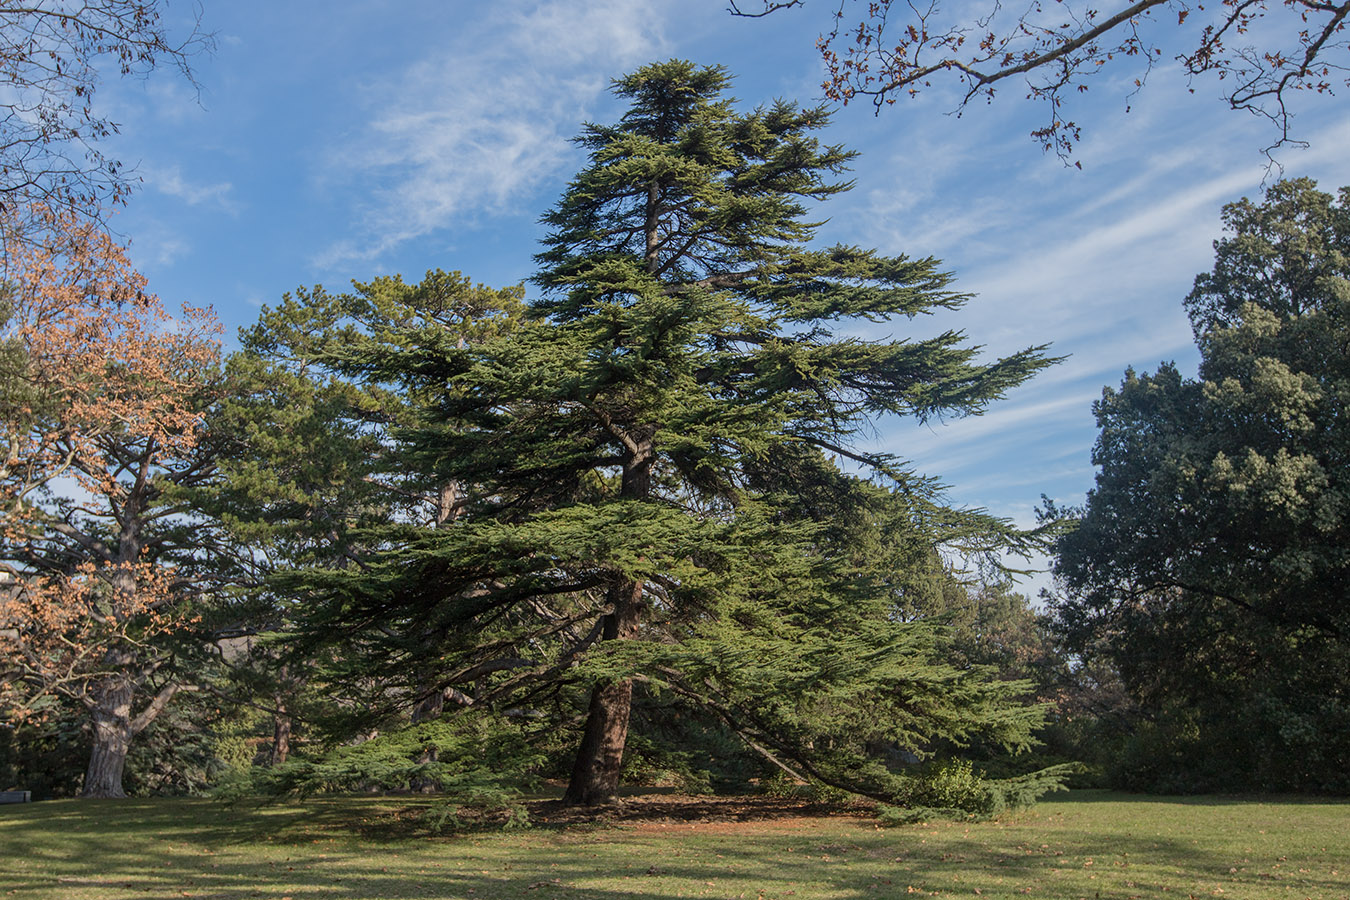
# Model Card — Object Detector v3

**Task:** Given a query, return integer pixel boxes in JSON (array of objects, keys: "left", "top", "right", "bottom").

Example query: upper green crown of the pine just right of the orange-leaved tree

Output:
[{"left": 209, "top": 270, "right": 520, "bottom": 563}]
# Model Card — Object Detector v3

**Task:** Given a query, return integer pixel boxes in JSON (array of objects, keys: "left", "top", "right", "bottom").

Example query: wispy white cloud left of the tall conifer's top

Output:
[{"left": 315, "top": 0, "right": 667, "bottom": 266}]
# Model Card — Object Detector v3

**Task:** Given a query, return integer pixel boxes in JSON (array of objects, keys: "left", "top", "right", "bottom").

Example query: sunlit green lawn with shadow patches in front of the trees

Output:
[{"left": 0, "top": 792, "right": 1350, "bottom": 900}]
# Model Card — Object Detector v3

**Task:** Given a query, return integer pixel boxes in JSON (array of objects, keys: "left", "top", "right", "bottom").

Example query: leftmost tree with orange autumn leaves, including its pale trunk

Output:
[{"left": 0, "top": 207, "right": 217, "bottom": 796}]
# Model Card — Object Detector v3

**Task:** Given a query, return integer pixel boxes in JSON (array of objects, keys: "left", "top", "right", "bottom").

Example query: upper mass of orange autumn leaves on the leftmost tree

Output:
[{"left": 0, "top": 206, "right": 220, "bottom": 518}]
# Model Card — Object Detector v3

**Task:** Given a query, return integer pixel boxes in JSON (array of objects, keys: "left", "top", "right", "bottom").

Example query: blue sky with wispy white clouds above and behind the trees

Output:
[{"left": 100, "top": 0, "right": 1350, "bottom": 591}]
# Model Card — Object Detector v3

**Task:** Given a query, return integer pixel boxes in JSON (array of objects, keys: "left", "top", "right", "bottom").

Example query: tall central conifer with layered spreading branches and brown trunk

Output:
[{"left": 292, "top": 61, "right": 1049, "bottom": 804}]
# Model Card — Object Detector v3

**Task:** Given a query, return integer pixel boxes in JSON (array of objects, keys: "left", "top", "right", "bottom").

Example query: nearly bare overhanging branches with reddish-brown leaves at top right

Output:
[{"left": 730, "top": 0, "right": 1350, "bottom": 158}]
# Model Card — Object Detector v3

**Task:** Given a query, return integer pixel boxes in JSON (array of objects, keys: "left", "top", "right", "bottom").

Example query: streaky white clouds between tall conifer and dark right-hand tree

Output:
[{"left": 860, "top": 109, "right": 1350, "bottom": 534}]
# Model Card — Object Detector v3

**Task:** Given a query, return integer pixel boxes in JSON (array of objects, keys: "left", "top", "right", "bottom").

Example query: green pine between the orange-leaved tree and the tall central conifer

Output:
[{"left": 197, "top": 271, "right": 521, "bottom": 764}]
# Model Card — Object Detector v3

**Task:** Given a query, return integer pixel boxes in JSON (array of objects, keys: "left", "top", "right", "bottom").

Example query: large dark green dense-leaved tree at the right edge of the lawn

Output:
[{"left": 1056, "top": 179, "right": 1350, "bottom": 791}]
